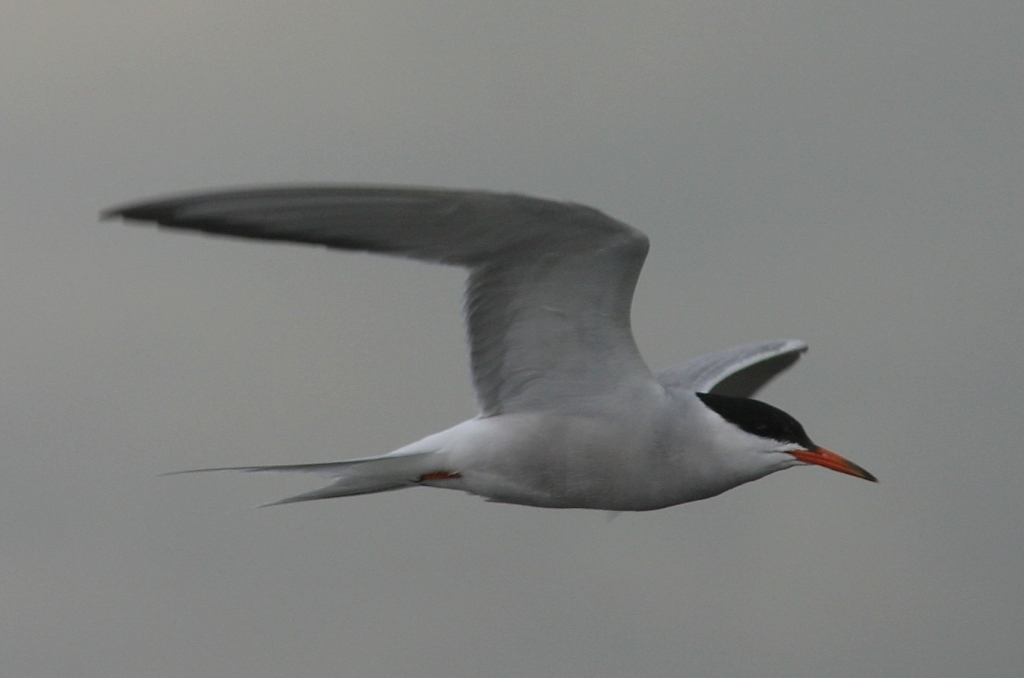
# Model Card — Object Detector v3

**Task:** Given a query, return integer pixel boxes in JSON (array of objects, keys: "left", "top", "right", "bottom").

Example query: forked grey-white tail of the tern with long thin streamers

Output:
[{"left": 167, "top": 450, "right": 442, "bottom": 506}]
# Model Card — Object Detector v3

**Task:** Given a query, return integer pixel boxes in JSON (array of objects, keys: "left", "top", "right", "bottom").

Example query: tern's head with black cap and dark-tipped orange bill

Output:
[{"left": 696, "top": 393, "right": 878, "bottom": 482}]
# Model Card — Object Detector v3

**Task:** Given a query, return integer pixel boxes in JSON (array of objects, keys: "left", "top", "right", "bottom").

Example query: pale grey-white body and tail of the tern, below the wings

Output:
[{"left": 251, "top": 384, "right": 796, "bottom": 511}]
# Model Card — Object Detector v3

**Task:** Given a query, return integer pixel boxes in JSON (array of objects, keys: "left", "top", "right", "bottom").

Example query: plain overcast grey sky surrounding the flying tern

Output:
[{"left": 0, "top": 0, "right": 1024, "bottom": 678}]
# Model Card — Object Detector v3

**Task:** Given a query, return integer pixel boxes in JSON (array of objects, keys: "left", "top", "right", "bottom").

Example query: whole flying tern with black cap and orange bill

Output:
[{"left": 101, "top": 184, "right": 878, "bottom": 513}]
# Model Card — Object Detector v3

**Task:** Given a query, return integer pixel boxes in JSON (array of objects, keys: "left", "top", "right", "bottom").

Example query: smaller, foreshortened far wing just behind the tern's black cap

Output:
[{"left": 657, "top": 339, "right": 807, "bottom": 397}]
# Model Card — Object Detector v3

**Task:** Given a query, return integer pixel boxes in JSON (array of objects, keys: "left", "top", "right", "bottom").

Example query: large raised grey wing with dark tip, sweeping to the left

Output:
[{"left": 103, "top": 186, "right": 652, "bottom": 415}]
